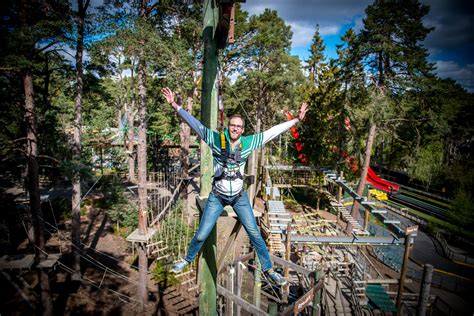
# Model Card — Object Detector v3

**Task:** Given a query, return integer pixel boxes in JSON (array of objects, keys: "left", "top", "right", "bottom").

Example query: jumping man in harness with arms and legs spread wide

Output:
[{"left": 162, "top": 88, "right": 308, "bottom": 285}]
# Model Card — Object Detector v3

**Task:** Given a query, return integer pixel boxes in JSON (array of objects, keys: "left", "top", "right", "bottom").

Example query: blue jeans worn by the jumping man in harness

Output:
[{"left": 184, "top": 192, "right": 272, "bottom": 271}]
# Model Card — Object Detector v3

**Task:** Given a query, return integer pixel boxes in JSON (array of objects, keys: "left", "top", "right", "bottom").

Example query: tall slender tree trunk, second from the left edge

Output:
[{"left": 71, "top": 0, "right": 89, "bottom": 280}]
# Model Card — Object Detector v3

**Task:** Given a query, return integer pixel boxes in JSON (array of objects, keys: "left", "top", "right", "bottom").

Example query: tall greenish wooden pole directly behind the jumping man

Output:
[{"left": 198, "top": 0, "right": 219, "bottom": 315}]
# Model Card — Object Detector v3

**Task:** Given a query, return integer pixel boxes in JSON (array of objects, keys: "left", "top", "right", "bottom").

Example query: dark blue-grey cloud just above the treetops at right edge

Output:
[{"left": 436, "top": 60, "right": 474, "bottom": 92}]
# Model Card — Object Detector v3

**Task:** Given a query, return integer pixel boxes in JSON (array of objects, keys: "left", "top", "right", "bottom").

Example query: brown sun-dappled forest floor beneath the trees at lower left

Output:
[{"left": 0, "top": 184, "right": 168, "bottom": 315}]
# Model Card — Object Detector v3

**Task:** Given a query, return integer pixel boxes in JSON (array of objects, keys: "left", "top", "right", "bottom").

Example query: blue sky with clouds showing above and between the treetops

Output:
[{"left": 242, "top": 0, "right": 474, "bottom": 92}]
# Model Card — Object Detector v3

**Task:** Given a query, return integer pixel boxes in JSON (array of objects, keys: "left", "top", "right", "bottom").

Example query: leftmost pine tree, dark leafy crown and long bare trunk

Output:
[{"left": 0, "top": 0, "right": 68, "bottom": 315}]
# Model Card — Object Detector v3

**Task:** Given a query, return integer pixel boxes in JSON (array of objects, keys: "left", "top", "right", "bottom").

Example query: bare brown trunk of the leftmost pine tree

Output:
[{"left": 23, "top": 73, "right": 53, "bottom": 315}]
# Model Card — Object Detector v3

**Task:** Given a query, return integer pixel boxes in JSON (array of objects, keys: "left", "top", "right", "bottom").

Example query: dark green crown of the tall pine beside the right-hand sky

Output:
[{"left": 358, "top": 0, "right": 433, "bottom": 89}]
